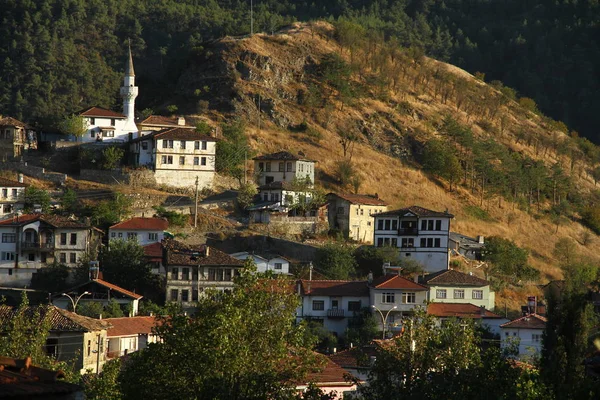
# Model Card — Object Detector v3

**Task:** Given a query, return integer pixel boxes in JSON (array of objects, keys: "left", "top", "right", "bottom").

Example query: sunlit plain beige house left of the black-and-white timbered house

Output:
[{"left": 327, "top": 193, "right": 388, "bottom": 243}]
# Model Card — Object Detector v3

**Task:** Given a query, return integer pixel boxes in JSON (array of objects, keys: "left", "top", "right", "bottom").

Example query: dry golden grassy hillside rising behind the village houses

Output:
[{"left": 178, "top": 22, "right": 599, "bottom": 305}]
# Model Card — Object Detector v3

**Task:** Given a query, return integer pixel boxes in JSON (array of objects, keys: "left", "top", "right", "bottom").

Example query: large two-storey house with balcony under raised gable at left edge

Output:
[{"left": 0, "top": 214, "right": 102, "bottom": 287}]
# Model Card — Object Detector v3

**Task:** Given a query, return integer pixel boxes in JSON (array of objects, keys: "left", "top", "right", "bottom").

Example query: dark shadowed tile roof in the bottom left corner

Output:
[{"left": 0, "top": 356, "right": 82, "bottom": 399}]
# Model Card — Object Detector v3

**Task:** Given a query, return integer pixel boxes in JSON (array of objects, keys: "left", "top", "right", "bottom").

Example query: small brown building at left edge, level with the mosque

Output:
[{"left": 0, "top": 115, "right": 37, "bottom": 161}]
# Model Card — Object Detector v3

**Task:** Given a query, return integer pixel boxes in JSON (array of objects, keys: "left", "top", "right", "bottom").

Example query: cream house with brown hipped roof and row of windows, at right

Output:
[{"left": 420, "top": 269, "right": 496, "bottom": 310}]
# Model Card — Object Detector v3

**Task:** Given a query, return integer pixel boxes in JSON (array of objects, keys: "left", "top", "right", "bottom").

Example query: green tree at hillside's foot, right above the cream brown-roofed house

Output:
[{"left": 484, "top": 236, "right": 539, "bottom": 281}]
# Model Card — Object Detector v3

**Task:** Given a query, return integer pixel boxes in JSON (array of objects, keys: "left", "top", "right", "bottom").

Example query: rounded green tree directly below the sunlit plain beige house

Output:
[{"left": 315, "top": 242, "right": 356, "bottom": 279}]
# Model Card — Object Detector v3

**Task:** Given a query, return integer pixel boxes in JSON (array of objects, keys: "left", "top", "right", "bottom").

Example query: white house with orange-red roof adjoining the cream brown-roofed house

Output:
[{"left": 369, "top": 274, "right": 429, "bottom": 332}]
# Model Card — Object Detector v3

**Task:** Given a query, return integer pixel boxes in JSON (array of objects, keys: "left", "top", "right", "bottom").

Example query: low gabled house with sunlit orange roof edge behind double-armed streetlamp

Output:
[{"left": 52, "top": 278, "right": 143, "bottom": 317}]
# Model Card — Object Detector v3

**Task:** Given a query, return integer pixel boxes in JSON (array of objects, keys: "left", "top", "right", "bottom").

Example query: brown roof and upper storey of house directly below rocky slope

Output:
[{"left": 254, "top": 151, "right": 315, "bottom": 186}]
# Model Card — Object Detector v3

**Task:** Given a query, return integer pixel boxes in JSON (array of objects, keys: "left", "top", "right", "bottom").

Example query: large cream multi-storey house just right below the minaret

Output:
[{"left": 129, "top": 127, "right": 217, "bottom": 188}]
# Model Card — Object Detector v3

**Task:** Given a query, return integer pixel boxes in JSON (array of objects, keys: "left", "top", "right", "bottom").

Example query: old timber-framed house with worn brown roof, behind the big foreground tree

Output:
[{"left": 162, "top": 239, "right": 244, "bottom": 310}]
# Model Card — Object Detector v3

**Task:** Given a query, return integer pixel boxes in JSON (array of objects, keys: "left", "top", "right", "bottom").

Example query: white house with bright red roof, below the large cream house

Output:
[{"left": 108, "top": 217, "right": 169, "bottom": 246}]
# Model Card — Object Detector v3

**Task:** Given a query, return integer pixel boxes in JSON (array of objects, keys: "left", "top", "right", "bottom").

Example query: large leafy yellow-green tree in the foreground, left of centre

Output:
[{"left": 119, "top": 271, "right": 318, "bottom": 400}]
